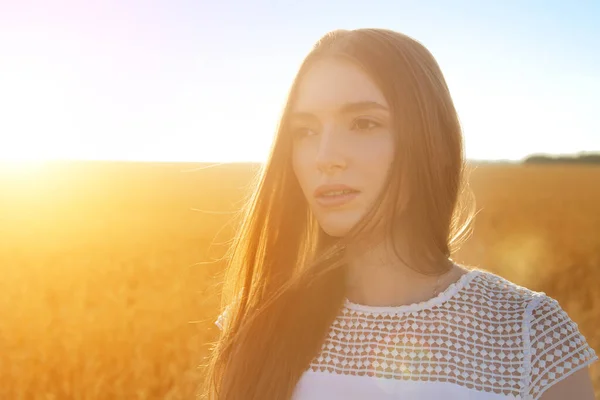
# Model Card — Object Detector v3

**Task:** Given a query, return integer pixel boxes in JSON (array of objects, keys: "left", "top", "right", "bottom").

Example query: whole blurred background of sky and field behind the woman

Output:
[{"left": 0, "top": 0, "right": 600, "bottom": 400}]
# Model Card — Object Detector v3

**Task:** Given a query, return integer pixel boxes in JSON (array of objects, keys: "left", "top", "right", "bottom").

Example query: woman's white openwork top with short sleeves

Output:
[{"left": 216, "top": 269, "right": 598, "bottom": 400}]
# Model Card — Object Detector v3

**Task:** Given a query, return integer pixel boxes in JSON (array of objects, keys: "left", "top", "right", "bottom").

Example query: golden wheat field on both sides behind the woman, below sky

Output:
[{"left": 0, "top": 162, "right": 600, "bottom": 400}]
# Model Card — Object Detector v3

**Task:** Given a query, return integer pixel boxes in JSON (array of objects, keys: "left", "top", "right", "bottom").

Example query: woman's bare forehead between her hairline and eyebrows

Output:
[{"left": 292, "top": 58, "right": 388, "bottom": 114}]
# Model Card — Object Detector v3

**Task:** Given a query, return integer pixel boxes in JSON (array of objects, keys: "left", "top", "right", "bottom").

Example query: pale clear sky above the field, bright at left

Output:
[{"left": 0, "top": 0, "right": 600, "bottom": 161}]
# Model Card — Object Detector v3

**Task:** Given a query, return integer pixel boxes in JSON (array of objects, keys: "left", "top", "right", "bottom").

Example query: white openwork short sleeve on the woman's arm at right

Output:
[{"left": 526, "top": 294, "right": 598, "bottom": 399}]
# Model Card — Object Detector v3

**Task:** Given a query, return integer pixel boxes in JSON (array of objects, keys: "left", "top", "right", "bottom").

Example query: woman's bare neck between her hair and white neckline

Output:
[{"left": 346, "top": 238, "right": 466, "bottom": 306}]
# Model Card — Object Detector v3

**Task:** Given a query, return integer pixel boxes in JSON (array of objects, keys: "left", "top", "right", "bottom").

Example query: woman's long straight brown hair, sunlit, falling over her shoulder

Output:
[{"left": 203, "top": 29, "right": 473, "bottom": 400}]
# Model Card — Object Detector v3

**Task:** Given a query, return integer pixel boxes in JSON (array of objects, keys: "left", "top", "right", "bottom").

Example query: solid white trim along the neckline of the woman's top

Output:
[{"left": 344, "top": 269, "right": 481, "bottom": 314}]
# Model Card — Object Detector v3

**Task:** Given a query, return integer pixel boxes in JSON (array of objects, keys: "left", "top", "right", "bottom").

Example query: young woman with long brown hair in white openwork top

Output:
[{"left": 204, "top": 29, "right": 597, "bottom": 400}]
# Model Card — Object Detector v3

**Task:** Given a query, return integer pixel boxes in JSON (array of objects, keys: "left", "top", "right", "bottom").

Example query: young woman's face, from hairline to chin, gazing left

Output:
[{"left": 289, "top": 59, "right": 394, "bottom": 237}]
